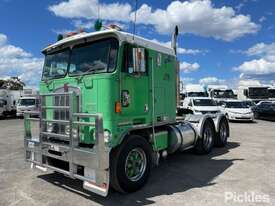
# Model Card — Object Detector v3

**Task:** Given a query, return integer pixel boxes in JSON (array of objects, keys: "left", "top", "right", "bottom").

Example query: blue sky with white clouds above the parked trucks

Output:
[{"left": 0, "top": 0, "right": 275, "bottom": 87}]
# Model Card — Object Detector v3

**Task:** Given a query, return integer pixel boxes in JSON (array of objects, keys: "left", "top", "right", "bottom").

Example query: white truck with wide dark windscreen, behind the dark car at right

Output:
[{"left": 238, "top": 85, "right": 269, "bottom": 103}]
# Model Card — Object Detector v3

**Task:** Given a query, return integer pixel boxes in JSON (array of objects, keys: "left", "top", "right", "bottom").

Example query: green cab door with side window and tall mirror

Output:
[{"left": 121, "top": 44, "right": 149, "bottom": 124}]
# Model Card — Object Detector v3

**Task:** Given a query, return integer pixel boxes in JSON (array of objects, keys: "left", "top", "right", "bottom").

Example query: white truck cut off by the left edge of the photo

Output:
[{"left": 0, "top": 89, "right": 22, "bottom": 117}]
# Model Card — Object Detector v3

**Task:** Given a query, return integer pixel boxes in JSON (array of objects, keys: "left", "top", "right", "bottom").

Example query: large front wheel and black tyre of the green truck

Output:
[{"left": 110, "top": 135, "right": 152, "bottom": 193}]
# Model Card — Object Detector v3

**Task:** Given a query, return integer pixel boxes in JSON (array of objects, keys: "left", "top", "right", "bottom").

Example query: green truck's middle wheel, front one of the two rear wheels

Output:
[{"left": 195, "top": 120, "right": 215, "bottom": 154}]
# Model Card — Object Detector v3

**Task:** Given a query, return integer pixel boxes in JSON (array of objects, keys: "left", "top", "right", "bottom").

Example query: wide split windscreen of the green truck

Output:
[{"left": 42, "top": 38, "right": 118, "bottom": 80}]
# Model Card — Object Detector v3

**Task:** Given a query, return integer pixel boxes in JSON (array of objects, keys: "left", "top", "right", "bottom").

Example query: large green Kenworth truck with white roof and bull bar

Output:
[{"left": 24, "top": 26, "right": 229, "bottom": 196}]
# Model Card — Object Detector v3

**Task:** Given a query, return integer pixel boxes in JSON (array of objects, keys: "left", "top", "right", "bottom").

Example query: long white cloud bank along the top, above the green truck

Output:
[{"left": 49, "top": 0, "right": 260, "bottom": 41}]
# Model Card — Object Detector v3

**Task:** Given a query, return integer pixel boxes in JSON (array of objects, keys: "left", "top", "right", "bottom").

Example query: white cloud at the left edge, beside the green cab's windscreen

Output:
[{"left": 0, "top": 34, "right": 43, "bottom": 85}]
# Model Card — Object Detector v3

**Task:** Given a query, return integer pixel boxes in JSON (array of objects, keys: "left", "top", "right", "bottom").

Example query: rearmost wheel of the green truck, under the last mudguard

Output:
[{"left": 215, "top": 118, "right": 229, "bottom": 147}]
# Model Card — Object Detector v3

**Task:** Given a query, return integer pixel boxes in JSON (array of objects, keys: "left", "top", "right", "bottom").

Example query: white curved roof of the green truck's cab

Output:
[{"left": 42, "top": 29, "right": 175, "bottom": 56}]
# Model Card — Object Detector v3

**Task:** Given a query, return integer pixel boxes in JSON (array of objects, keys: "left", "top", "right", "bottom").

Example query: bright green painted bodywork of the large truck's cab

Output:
[{"left": 40, "top": 34, "right": 176, "bottom": 149}]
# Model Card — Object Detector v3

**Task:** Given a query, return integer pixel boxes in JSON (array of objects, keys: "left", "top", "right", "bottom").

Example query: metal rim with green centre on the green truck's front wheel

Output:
[{"left": 125, "top": 148, "right": 147, "bottom": 182}]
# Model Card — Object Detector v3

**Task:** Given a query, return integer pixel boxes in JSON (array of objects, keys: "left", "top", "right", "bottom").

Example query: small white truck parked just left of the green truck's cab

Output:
[{"left": 16, "top": 89, "right": 39, "bottom": 118}]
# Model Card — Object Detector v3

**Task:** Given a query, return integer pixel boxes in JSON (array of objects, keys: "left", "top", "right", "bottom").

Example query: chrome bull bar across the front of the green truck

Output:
[{"left": 24, "top": 92, "right": 110, "bottom": 196}]
